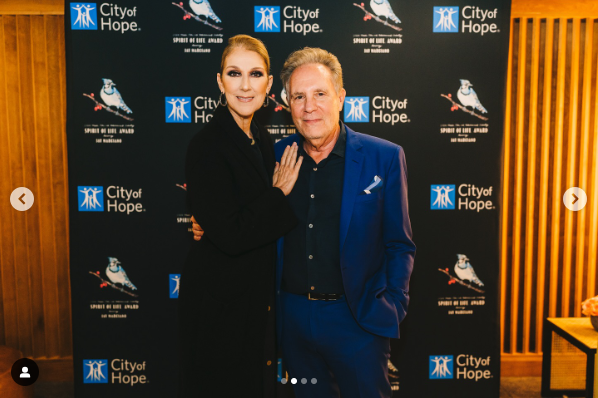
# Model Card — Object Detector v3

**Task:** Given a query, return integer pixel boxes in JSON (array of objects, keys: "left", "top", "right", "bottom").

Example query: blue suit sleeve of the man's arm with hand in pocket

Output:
[{"left": 383, "top": 147, "right": 415, "bottom": 322}]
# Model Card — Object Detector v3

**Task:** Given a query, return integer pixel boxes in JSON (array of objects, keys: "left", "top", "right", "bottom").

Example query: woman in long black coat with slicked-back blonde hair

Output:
[{"left": 179, "top": 35, "right": 302, "bottom": 398}]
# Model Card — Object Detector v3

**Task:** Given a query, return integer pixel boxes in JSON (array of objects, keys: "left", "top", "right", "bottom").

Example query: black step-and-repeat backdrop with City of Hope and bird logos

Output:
[{"left": 65, "top": 0, "right": 510, "bottom": 398}]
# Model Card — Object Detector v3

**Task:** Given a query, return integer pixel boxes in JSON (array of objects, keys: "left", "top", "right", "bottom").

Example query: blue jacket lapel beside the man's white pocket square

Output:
[{"left": 340, "top": 126, "right": 363, "bottom": 252}]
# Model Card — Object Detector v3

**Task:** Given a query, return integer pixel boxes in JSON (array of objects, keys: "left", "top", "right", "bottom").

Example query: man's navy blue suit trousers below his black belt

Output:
[{"left": 281, "top": 292, "right": 392, "bottom": 398}]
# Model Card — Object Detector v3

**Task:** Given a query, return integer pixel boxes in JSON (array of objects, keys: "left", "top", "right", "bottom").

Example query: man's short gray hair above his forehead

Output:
[{"left": 280, "top": 47, "right": 343, "bottom": 94}]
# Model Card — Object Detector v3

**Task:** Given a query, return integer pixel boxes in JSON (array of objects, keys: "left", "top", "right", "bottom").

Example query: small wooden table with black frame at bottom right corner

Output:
[{"left": 542, "top": 317, "right": 598, "bottom": 398}]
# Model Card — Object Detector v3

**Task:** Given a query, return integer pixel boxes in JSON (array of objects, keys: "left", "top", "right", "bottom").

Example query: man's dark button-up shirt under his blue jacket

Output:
[{"left": 282, "top": 123, "right": 347, "bottom": 294}]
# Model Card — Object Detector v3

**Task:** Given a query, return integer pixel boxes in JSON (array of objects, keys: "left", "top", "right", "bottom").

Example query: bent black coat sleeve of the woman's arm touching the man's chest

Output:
[{"left": 187, "top": 145, "right": 297, "bottom": 256}]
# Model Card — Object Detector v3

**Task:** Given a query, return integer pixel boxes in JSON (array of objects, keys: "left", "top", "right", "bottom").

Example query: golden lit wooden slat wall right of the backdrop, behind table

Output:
[{"left": 501, "top": 15, "right": 598, "bottom": 366}]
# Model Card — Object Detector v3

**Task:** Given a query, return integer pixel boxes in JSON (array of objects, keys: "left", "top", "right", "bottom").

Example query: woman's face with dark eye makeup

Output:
[{"left": 218, "top": 48, "right": 272, "bottom": 118}]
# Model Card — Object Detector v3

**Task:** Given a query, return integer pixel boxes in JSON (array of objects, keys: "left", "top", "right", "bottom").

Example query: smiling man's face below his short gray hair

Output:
[{"left": 289, "top": 64, "right": 345, "bottom": 141}]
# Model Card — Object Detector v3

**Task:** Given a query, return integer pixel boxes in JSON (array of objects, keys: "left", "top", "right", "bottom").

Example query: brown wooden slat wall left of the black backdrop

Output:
[{"left": 0, "top": 15, "right": 72, "bottom": 359}]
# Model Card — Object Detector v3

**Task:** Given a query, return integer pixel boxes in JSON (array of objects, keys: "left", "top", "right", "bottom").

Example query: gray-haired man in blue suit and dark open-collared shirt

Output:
[{"left": 194, "top": 48, "right": 415, "bottom": 398}]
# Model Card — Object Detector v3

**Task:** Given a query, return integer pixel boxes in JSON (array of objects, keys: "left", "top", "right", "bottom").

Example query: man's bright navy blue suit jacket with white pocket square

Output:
[{"left": 274, "top": 126, "right": 415, "bottom": 341}]
